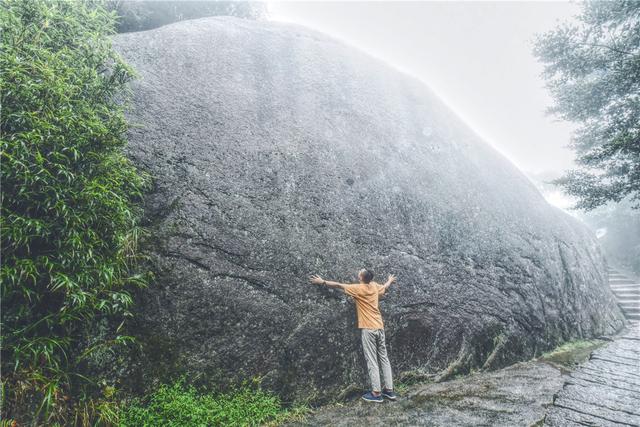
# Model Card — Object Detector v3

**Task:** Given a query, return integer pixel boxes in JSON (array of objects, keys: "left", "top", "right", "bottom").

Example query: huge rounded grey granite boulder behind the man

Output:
[{"left": 114, "top": 17, "right": 623, "bottom": 400}]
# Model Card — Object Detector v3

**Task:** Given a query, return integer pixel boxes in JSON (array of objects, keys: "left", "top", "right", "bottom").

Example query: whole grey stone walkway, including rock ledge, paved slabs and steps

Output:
[{"left": 291, "top": 271, "right": 640, "bottom": 427}]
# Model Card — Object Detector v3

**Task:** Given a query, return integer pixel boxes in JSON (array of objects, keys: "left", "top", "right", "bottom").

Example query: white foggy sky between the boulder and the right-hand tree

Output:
[{"left": 269, "top": 2, "right": 579, "bottom": 182}]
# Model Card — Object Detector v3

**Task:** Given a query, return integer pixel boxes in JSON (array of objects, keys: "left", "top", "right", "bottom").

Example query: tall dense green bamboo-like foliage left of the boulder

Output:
[{"left": 0, "top": 0, "right": 149, "bottom": 423}]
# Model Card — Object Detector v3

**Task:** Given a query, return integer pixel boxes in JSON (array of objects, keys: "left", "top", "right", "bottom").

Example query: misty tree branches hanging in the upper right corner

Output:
[{"left": 534, "top": 0, "right": 640, "bottom": 210}]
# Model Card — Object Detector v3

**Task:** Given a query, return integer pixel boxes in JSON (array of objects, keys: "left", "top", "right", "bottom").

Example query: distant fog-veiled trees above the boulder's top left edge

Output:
[{"left": 107, "top": 0, "right": 266, "bottom": 33}]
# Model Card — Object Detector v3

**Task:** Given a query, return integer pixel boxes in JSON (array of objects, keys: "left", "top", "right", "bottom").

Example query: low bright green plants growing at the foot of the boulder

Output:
[{"left": 120, "top": 380, "right": 303, "bottom": 427}]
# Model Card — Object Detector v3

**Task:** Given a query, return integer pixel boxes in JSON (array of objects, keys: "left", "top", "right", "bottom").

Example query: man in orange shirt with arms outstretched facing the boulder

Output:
[{"left": 310, "top": 269, "right": 397, "bottom": 403}]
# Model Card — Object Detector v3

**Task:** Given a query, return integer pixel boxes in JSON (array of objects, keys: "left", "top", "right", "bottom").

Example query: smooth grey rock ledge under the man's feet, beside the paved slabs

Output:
[{"left": 287, "top": 362, "right": 563, "bottom": 427}]
